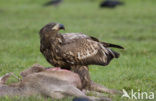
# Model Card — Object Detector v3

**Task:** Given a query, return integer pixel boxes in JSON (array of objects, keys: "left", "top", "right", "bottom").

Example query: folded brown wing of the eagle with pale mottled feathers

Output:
[{"left": 61, "top": 36, "right": 119, "bottom": 65}]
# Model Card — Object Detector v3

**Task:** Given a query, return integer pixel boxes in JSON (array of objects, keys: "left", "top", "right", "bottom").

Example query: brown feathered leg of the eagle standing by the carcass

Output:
[{"left": 71, "top": 66, "right": 91, "bottom": 90}]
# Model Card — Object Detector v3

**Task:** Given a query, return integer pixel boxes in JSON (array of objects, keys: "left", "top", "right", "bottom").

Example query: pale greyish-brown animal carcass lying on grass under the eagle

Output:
[{"left": 0, "top": 70, "right": 110, "bottom": 101}]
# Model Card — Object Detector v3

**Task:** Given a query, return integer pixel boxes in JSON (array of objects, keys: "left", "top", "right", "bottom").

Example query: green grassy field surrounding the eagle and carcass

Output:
[{"left": 0, "top": 0, "right": 156, "bottom": 101}]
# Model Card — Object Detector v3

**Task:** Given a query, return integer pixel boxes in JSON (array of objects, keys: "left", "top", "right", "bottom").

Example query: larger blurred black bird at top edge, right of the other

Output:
[{"left": 100, "top": 0, "right": 124, "bottom": 8}]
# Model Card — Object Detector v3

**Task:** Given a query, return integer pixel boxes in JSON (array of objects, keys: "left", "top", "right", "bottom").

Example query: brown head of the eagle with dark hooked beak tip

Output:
[{"left": 40, "top": 22, "right": 65, "bottom": 37}]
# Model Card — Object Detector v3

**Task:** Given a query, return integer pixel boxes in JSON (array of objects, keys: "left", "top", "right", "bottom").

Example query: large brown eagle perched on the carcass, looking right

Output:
[{"left": 39, "top": 22, "right": 124, "bottom": 88}]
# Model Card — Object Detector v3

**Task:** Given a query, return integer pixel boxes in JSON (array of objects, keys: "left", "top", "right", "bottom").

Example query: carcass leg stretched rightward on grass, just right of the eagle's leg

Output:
[{"left": 90, "top": 81, "right": 122, "bottom": 94}]
